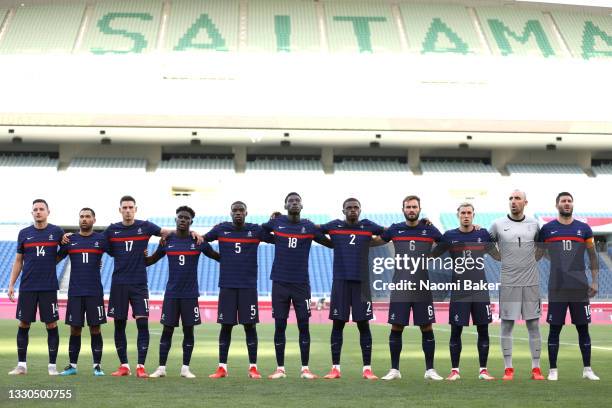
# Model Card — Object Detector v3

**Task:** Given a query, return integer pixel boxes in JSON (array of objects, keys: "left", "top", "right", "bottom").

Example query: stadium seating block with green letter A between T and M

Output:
[{"left": 399, "top": 3, "right": 485, "bottom": 55}]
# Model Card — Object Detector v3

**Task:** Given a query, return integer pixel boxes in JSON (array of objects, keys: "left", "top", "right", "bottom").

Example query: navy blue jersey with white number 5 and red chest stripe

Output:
[{"left": 204, "top": 222, "right": 271, "bottom": 288}]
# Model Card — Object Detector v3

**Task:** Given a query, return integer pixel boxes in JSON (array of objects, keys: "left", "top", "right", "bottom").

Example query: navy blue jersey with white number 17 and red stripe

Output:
[{"left": 104, "top": 220, "right": 161, "bottom": 285}]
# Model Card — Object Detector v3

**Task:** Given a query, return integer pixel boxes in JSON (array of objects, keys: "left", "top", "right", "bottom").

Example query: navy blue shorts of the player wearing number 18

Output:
[{"left": 272, "top": 281, "right": 310, "bottom": 320}]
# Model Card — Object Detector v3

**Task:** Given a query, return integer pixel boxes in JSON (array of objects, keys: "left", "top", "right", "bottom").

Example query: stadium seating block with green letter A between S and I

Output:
[{"left": 164, "top": 0, "right": 240, "bottom": 52}]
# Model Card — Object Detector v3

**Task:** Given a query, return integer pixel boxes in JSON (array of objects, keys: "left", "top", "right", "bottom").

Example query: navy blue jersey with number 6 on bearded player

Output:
[{"left": 380, "top": 222, "right": 442, "bottom": 282}]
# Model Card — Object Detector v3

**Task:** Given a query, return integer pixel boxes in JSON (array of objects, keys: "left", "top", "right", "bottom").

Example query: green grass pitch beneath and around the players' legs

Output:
[{"left": 0, "top": 320, "right": 612, "bottom": 408}]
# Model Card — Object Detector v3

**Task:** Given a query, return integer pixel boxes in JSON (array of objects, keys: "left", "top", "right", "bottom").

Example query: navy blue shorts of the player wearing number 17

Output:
[{"left": 108, "top": 284, "right": 149, "bottom": 320}]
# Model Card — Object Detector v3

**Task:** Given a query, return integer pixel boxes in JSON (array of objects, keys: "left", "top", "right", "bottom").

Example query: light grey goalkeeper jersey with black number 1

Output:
[{"left": 489, "top": 216, "right": 540, "bottom": 286}]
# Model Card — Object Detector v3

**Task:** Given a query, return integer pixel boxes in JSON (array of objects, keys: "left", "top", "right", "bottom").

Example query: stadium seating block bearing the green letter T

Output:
[{"left": 323, "top": 1, "right": 401, "bottom": 53}]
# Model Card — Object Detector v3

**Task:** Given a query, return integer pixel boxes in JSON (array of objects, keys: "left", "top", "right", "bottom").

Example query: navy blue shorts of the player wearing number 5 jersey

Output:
[{"left": 217, "top": 288, "right": 259, "bottom": 324}]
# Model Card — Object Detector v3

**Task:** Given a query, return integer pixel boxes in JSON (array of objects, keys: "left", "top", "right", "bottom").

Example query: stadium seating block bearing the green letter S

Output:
[{"left": 80, "top": 0, "right": 162, "bottom": 55}]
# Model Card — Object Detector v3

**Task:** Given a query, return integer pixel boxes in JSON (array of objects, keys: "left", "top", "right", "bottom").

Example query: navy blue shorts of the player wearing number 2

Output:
[{"left": 329, "top": 279, "right": 373, "bottom": 322}]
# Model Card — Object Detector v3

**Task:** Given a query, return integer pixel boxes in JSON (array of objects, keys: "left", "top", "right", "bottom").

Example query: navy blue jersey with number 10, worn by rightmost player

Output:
[{"left": 538, "top": 220, "right": 593, "bottom": 290}]
